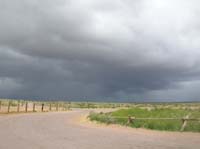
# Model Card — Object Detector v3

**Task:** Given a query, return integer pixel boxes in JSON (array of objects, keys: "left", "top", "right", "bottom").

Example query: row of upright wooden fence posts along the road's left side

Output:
[{"left": 0, "top": 100, "right": 70, "bottom": 113}]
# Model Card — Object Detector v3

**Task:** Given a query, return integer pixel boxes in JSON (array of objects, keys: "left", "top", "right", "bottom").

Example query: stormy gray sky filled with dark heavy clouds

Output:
[{"left": 0, "top": 0, "right": 200, "bottom": 101}]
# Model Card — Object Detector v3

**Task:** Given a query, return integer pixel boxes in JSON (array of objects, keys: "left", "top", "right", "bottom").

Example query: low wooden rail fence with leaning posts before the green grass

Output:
[{"left": 112, "top": 115, "right": 200, "bottom": 131}]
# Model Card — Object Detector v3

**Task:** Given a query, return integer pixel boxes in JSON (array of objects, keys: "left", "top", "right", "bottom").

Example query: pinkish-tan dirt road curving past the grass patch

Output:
[{"left": 0, "top": 110, "right": 200, "bottom": 149}]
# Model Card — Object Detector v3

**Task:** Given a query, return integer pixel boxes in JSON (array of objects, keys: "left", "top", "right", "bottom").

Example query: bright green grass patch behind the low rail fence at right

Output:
[{"left": 89, "top": 108, "right": 200, "bottom": 132}]
